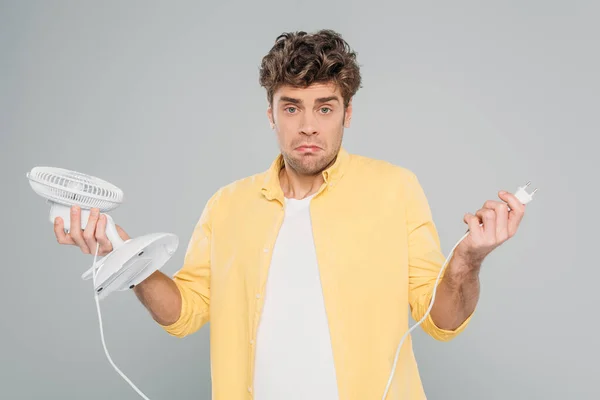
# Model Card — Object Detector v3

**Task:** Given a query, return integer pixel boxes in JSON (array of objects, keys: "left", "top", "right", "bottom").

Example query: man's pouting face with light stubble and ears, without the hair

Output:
[{"left": 267, "top": 84, "right": 352, "bottom": 175}]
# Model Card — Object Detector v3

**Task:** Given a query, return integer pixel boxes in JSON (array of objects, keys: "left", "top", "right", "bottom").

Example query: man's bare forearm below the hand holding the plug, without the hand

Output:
[{"left": 430, "top": 256, "right": 481, "bottom": 330}]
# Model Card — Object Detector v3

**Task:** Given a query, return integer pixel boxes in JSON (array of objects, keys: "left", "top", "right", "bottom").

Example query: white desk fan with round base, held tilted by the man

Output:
[{"left": 26, "top": 167, "right": 179, "bottom": 299}]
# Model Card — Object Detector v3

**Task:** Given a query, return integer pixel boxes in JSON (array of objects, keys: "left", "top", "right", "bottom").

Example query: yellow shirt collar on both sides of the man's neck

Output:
[{"left": 261, "top": 146, "right": 350, "bottom": 203}]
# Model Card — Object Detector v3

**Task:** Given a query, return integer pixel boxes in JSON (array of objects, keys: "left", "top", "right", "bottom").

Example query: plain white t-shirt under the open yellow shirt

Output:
[{"left": 254, "top": 192, "right": 338, "bottom": 400}]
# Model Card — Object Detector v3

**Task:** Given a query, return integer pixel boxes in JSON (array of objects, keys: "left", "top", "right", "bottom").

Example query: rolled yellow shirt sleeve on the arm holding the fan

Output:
[{"left": 160, "top": 191, "right": 216, "bottom": 338}]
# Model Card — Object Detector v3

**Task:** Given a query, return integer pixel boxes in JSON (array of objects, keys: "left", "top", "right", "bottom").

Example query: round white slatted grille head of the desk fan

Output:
[{"left": 27, "top": 167, "right": 123, "bottom": 212}]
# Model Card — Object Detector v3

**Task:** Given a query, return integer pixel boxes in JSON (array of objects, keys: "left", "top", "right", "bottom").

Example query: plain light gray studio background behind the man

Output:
[{"left": 0, "top": 0, "right": 600, "bottom": 400}]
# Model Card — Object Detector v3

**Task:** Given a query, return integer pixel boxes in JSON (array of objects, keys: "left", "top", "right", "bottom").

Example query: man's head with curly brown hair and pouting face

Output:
[{"left": 260, "top": 30, "right": 361, "bottom": 175}]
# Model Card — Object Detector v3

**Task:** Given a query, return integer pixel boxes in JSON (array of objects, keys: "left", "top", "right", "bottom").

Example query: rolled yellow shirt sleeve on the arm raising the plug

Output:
[{"left": 406, "top": 173, "right": 472, "bottom": 341}]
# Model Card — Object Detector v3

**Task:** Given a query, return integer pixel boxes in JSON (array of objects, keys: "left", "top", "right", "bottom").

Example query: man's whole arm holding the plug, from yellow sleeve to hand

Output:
[{"left": 403, "top": 173, "right": 524, "bottom": 341}]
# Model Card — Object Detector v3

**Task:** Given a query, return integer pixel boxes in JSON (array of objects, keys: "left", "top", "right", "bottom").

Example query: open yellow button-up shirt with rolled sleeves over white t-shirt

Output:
[{"left": 163, "top": 148, "right": 471, "bottom": 400}]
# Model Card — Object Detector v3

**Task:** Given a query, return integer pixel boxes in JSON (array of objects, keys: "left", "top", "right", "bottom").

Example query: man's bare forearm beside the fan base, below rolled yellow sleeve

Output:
[{"left": 133, "top": 271, "right": 181, "bottom": 325}]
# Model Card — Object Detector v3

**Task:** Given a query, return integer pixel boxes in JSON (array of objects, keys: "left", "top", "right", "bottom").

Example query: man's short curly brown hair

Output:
[{"left": 259, "top": 29, "right": 361, "bottom": 107}]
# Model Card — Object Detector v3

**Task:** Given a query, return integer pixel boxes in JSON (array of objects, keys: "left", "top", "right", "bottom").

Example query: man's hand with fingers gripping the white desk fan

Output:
[{"left": 54, "top": 206, "right": 129, "bottom": 257}]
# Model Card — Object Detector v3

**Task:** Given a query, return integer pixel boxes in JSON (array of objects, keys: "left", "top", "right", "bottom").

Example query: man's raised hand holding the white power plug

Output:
[{"left": 454, "top": 191, "right": 525, "bottom": 268}]
